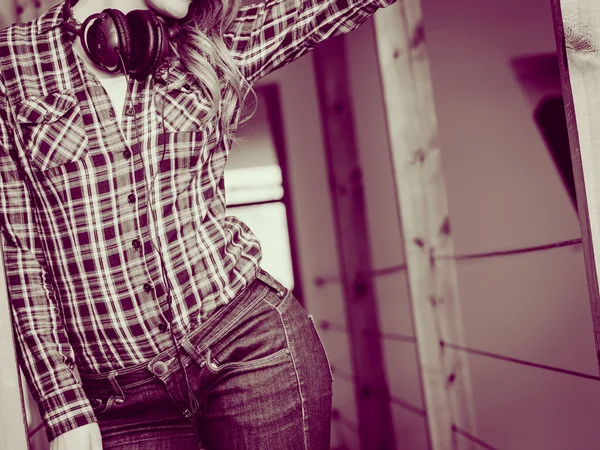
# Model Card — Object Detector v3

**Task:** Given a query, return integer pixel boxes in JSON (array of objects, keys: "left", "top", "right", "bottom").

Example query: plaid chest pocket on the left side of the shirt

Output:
[{"left": 17, "top": 91, "right": 88, "bottom": 171}]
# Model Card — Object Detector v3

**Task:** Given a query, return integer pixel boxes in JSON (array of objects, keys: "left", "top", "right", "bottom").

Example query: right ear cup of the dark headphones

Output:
[{"left": 126, "top": 10, "right": 168, "bottom": 79}]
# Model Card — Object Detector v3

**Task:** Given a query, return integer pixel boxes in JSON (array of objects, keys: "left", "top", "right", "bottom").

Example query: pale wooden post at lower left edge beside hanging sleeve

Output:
[{"left": 0, "top": 246, "right": 29, "bottom": 450}]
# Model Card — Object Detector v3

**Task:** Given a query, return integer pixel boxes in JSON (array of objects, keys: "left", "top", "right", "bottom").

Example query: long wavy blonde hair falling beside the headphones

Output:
[{"left": 174, "top": 0, "right": 255, "bottom": 138}]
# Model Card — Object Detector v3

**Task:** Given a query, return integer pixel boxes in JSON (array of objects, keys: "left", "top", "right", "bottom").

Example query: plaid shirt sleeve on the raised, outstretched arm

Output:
[{"left": 224, "top": 0, "right": 395, "bottom": 84}]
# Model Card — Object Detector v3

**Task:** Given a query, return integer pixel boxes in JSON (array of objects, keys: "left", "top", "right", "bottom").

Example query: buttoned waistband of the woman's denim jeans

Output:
[{"left": 79, "top": 269, "right": 288, "bottom": 395}]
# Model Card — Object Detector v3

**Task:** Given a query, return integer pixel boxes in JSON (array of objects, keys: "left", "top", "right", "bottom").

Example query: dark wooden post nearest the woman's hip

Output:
[{"left": 314, "top": 36, "right": 396, "bottom": 450}]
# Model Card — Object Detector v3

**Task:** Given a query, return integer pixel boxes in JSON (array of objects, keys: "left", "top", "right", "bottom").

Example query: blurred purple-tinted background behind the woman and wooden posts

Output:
[{"left": 0, "top": 0, "right": 600, "bottom": 450}]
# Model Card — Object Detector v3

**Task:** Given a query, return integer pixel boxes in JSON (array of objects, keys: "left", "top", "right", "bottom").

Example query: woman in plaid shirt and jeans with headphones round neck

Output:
[{"left": 0, "top": 0, "right": 392, "bottom": 450}]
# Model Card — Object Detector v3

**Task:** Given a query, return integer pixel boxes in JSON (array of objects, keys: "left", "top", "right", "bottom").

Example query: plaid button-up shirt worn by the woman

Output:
[{"left": 0, "top": 0, "right": 393, "bottom": 439}]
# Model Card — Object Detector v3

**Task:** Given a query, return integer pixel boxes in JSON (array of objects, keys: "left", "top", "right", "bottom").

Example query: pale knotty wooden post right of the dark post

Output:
[{"left": 375, "top": 0, "right": 476, "bottom": 450}]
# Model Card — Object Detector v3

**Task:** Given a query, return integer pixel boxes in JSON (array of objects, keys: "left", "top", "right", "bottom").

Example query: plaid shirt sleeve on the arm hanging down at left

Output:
[{"left": 0, "top": 80, "right": 96, "bottom": 440}]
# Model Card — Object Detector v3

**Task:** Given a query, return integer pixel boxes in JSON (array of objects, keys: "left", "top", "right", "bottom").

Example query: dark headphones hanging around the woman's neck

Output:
[{"left": 63, "top": 0, "right": 181, "bottom": 80}]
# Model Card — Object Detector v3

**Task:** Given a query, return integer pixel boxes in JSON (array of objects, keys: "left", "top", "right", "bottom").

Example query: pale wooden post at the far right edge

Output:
[{"left": 552, "top": 0, "right": 600, "bottom": 368}]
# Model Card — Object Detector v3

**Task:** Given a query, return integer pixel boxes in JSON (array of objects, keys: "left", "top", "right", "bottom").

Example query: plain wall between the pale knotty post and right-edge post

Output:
[{"left": 423, "top": 0, "right": 600, "bottom": 450}]
